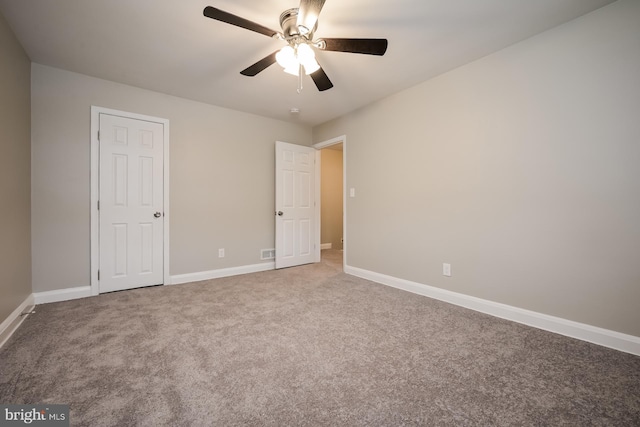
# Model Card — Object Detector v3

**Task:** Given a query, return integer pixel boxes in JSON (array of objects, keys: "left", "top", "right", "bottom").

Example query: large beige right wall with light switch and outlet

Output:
[{"left": 314, "top": 0, "right": 640, "bottom": 336}]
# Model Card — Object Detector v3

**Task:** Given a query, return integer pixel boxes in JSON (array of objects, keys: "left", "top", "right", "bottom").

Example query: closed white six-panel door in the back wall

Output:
[{"left": 99, "top": 113, "right": 164, "bottom": 293}]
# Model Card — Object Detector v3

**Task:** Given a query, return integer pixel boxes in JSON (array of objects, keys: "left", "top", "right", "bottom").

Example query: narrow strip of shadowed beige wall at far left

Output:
[{"left": 0, "top": 14, "right": 31, "bottom": 323}]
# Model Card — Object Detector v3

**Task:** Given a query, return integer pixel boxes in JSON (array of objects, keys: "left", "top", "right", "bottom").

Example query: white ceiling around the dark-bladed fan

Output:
[{"left": 0, "top": 0, "right": 613, "bottom": 125}]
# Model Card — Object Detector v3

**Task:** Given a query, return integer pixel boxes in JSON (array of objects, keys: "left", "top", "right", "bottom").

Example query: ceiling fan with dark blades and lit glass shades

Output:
[{"left": 203, "top": 0, "right": 388, "bottom": 92}]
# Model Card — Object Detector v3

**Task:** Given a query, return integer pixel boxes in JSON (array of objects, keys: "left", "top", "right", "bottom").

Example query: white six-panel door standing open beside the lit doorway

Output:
[{"left": 276, "top": 141, "right": 317, "bottom": 268}]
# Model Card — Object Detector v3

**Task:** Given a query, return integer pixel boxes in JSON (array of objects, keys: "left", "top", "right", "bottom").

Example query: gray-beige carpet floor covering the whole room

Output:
[{"left": 0, "top": 251, "right": 640, "bottom": 426}]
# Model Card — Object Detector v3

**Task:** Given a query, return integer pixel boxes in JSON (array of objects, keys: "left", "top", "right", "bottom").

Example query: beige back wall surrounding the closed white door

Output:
[{"left": 32, "top": 64, "right": 311, "bottom": 292}]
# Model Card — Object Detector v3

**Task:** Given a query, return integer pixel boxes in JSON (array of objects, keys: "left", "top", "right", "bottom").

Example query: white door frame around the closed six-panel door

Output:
[{"left": 91, "top": 105, "right": 171, "bottom": 295}]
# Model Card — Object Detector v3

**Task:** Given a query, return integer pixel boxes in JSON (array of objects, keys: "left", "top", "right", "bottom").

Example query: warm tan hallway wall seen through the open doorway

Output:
[{"left": 320, "top": 148, "right": 343, "bottom": 249}]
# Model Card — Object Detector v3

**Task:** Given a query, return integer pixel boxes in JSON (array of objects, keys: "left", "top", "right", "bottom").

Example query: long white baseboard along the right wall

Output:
[{"left": 344, "top": 266, "right": 640, "bottom": 356}]
